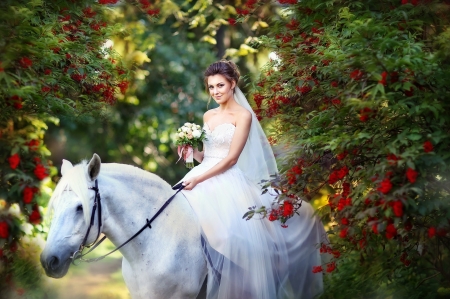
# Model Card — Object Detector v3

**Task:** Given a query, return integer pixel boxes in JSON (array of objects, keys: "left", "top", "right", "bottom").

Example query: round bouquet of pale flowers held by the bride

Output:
[{"left": 175, "top": 123, "right": 206, "bottom": 168}]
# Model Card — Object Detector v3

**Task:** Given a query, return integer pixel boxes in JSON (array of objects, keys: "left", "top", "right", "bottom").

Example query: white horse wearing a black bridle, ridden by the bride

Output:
[{"left": 41, "top": 154, "right": 207, "bottom": 299}]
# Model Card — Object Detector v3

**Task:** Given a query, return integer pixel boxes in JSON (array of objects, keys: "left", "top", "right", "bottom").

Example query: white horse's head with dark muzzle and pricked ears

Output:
[{"left": 41, "top": 154, "right": 101, "bottom": 278}]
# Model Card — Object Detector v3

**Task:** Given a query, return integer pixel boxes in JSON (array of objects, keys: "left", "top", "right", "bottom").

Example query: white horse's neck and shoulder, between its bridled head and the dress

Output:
[{"left": 93, "top": 165, "right": 206, "bottom": 298}]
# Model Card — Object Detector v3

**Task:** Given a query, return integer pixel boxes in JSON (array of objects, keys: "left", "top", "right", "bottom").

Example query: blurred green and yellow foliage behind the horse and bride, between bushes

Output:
[{"left": 46, "top": 1, "right": 271, "bottom": 183}]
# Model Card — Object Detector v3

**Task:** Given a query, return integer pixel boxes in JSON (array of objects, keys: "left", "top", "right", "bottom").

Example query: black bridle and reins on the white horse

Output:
[{"left": 70, "top": 180, "right": 184, "bottom": 264}]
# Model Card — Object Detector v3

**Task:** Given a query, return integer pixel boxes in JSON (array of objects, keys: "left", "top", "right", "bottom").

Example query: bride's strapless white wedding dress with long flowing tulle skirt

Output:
[{"left": 182, "top": 123, "right": 326, "bottom": 299}]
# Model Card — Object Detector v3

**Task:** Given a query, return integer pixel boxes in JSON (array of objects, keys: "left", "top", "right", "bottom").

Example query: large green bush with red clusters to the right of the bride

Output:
[{"left": 253, "top": 0, "right": 450, "bottom": 298}]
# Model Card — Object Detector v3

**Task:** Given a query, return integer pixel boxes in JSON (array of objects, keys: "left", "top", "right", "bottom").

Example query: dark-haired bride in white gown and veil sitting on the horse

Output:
[{"left": 178, "top": 60, "right": 325, "bottom": 299}]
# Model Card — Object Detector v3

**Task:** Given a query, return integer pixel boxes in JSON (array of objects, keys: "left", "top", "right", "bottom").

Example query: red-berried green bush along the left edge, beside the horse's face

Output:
[{"left": 0, "top": 0, "right": 128, "bottom": 293}]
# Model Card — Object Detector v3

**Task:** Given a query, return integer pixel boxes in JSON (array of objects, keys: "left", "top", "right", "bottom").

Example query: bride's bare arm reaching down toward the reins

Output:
[{"left": 183, "top": 111, "right": 252, "bottom": 190}]
